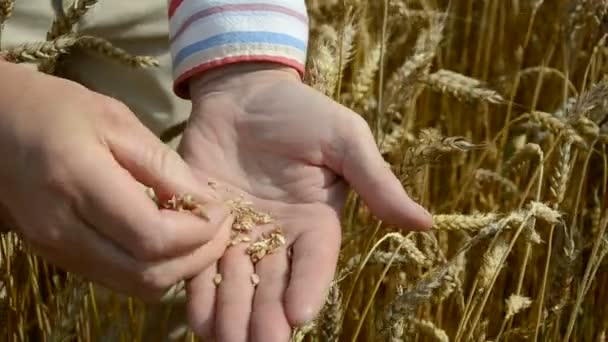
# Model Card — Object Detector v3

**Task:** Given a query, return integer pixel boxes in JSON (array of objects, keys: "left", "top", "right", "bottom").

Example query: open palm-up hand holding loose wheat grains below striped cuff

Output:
[{"left": 179, "top": 64, "right": 431, "bottom": 342}]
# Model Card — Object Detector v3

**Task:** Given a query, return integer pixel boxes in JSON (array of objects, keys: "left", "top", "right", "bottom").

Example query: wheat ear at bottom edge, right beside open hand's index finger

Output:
[{"left": 317, "top": 282, "right": 343, "bottom": 341}]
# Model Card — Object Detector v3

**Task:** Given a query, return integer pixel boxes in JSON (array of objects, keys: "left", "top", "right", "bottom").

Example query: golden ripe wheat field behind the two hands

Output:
[{"left": 0, "top": 0, "right": 608, "bottom": 342}]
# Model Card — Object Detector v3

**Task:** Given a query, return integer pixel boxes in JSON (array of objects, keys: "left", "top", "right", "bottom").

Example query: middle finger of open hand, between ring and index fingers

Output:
[{"left": 250, "top": 249, "right": 291, "bottom": 342}]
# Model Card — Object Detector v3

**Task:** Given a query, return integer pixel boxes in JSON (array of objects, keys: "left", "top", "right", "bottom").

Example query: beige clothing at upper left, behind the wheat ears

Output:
[{"left": 2, "top": 0, "right": 190, "bottom": 134}]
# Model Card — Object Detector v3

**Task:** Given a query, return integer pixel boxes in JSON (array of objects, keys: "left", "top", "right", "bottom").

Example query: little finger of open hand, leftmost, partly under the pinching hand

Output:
[{"left": 186, "top": 263, "right": 219, "bottom": 340}]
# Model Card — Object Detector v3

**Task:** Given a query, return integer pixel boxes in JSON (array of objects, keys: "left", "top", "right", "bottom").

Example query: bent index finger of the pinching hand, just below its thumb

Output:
[{"left": 74, "top": 149, "right": 229, "bottom": 260}]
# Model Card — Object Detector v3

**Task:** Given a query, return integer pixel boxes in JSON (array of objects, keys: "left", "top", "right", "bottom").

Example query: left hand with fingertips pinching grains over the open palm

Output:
[{"left": 0, "top": 61, "right": 231, "bottom": 299}]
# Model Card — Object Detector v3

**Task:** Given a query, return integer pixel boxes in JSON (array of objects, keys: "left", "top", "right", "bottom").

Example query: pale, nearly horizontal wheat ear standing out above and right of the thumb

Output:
[{"left": 420, "top": 69, "right": 504, "bottom": 103}]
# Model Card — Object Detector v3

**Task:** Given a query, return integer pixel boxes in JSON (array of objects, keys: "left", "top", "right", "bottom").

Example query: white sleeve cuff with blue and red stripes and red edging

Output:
[{"left": 169, "top": 0, "right": 308, "bottom": 99}]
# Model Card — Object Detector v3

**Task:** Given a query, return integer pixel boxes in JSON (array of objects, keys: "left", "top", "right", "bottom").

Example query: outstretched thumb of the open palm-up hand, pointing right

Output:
[{"left": 325, "top": 111, "right": 432, "bottom": 230}]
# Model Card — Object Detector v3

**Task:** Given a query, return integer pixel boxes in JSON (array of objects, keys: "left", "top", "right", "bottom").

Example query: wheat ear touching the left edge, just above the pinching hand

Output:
[{"left": 0, "top": 35, "right": 78, "bottom": 63}]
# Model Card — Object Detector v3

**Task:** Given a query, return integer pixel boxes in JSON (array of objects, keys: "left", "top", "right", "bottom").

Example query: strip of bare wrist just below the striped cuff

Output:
[{"left": 189, "top": 62, "right": 301, "bottom": 105}]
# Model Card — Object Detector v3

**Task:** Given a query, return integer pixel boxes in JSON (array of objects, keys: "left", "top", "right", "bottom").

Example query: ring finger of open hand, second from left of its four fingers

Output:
[{"left": 215, "top": 245, "right": 254, "bottom": 342}]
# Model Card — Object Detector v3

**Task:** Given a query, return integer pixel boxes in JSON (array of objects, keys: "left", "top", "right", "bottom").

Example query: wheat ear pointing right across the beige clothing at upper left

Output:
[{"left": 78, "top": 36, "right": 159, "bottom": 68}]
